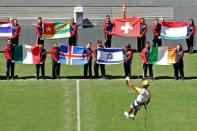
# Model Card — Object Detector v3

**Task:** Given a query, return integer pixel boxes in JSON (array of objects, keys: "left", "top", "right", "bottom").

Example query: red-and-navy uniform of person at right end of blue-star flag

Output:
[{"left": 124, "top": 48, "right": 133, "bottom": 78}]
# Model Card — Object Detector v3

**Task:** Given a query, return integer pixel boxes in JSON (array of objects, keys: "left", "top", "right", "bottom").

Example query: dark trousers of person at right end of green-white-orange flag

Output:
[{"left": 173, "top": 61, "right": 184, "bottom": 79}]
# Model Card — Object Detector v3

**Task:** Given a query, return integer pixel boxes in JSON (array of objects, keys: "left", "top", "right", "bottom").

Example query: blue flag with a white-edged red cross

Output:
[{"left": 59, "top": 44, "right": 87, "bottom": 66}]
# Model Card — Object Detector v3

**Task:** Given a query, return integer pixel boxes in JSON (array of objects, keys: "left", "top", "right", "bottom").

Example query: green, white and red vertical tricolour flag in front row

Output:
[{"left": 14, "top": 44, "right": 40, "bottom": 64}]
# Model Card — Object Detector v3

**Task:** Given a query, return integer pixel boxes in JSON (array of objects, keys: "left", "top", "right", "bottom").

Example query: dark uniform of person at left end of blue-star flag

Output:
[{"left": 94, "top": 46, "right": 105, "bottom": 79}]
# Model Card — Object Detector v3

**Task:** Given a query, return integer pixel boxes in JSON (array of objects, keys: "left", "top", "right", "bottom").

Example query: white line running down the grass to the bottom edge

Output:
[{"left": 76, "top": 80, "right": 81, "bottom": 131}]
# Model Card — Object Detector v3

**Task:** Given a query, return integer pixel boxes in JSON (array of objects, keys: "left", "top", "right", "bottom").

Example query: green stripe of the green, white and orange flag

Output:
[{"left": 148, "top": 47, "right": 158, "bottom": 64}]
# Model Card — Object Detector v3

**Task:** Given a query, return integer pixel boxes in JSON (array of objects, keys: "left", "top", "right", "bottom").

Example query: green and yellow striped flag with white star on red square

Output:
[{"left": 43, "top": 23, "right": 70, "bottom": 39}]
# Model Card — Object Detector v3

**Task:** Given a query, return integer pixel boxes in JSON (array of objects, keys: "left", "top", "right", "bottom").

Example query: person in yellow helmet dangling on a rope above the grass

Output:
[{"left": 124, "top": 77, "right": 151, "bottom": 119}]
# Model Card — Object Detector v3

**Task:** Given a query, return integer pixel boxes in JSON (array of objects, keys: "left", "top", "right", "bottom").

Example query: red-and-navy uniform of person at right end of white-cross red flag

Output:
[{"left": 137, "top": 23, "right": 148, "bottom": 52}]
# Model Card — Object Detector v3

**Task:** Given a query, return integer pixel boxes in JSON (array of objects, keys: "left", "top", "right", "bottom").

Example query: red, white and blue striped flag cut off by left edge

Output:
[{"left": 0, "top": 22, "right": 12, "bottom": 38}]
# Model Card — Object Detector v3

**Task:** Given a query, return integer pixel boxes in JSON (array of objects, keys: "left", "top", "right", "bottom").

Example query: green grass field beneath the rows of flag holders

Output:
[{"left": 0, "top": 53, "right": 197, "bottom": 131}]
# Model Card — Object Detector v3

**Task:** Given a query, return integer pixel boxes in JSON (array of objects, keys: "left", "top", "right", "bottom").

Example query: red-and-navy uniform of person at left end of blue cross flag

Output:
[{"left": 50, "top": 47, "right": 60, "bottom": 79}]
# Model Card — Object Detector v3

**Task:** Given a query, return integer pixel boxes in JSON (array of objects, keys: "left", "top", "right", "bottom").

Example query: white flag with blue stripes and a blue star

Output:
[{"left": 96, "top": 48, "right": 124, "bottom": 64}]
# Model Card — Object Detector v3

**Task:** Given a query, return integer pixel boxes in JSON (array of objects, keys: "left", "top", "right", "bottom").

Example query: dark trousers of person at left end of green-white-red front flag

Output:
[{"left": 6, "top": 60, "right": 15, "bottom": 79}]
